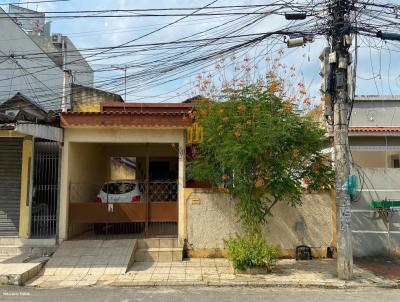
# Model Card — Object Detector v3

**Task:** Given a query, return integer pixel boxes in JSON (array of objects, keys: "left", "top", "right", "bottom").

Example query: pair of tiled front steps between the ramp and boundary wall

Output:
[{"left": 135, "top": 238, "right": 183, "bottom": 262}]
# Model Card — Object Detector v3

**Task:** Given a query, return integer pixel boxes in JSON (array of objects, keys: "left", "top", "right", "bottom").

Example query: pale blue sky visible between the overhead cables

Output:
[{"left": 0, "top": 0, "right": 400, "bottom": 102}]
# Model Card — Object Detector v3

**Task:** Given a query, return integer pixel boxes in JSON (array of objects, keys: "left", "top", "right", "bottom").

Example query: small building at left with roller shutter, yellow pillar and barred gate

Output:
[{"left": 0, "top": 93, "right": 62, "bottom": 239}]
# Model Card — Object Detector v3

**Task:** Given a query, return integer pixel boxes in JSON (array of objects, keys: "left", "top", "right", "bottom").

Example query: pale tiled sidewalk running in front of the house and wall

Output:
[{"left": 26, "top": 258, "right": 397, "bottom": 288}]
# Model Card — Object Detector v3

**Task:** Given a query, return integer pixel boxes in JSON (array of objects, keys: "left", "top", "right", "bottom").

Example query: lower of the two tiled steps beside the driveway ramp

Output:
[{"left": 135, "top": 247, "right": 183, "bottom": 262}]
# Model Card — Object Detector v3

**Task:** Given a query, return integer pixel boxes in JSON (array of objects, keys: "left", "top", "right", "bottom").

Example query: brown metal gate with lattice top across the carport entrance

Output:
[{"left": 68, "top": 158, "right": 178, "bottom": 238}]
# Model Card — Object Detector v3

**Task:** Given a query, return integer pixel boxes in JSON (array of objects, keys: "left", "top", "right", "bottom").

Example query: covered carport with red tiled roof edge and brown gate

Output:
[{"left": 59, "top": 103, "right": 192, "bottom": 244}]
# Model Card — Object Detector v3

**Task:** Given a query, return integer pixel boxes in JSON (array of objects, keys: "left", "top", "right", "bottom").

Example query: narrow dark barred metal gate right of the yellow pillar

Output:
[{"left": 30, "top": 140, "right": 60, "bottom": 238}]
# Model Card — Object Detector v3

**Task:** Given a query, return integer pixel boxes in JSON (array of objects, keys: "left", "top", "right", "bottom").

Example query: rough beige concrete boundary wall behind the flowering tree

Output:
[{"left": 185, "top": 189, "right": 336, "bottom": 257}]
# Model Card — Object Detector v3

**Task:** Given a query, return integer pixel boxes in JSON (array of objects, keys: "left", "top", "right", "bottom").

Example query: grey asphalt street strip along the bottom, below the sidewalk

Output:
[{"left": 0, "top": 286, "right": 400, "bottom": 302}]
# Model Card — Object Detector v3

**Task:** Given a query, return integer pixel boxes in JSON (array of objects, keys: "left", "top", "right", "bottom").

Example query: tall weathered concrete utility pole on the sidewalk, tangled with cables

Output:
[{"left": 329, "top": 0, "right": 353, "bottom": 280}]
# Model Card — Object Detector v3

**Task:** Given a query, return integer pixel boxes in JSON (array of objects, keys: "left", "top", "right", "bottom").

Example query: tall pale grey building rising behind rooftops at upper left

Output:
[{"left": 0, "top": 5, "right": 93, "bottom": 111}]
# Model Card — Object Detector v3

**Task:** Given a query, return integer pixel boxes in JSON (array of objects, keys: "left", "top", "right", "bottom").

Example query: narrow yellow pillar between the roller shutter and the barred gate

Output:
[{"left": 19, "top": 139, "right": 32, "bottom": 238}]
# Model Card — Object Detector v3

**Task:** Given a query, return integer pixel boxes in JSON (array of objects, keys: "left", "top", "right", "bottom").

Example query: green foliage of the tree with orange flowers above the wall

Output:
[{"left": 191, "top": 81, "right": 333, "bottom": 235}]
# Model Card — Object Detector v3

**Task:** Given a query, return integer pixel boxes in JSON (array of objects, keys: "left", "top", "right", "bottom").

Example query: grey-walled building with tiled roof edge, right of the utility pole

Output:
[{"left": 349, "top": 96, "right": 400, "bottom": 256}]
